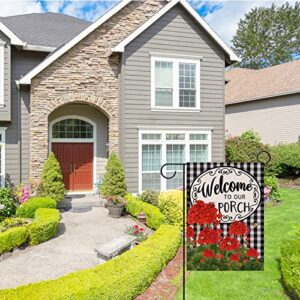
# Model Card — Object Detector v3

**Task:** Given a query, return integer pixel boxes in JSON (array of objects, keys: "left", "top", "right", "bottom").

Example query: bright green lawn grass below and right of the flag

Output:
[{"left": 177, "top": 189, "right": 300, "bottom": 300}]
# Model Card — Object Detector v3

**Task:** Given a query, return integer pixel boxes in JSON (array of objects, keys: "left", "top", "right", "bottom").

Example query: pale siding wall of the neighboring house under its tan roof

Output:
[{"left": 225, "top": 94, "right": 300, "bottom": 144}]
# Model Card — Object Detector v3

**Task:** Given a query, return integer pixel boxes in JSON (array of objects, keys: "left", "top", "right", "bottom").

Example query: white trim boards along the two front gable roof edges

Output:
[{"left": 17, "top": 0, "right": 239, "bottom": 85}]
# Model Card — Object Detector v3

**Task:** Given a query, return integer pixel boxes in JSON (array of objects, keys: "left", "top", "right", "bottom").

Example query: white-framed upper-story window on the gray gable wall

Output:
[{"left": 151, "top": 56, "right": 200, "bottom": 110}]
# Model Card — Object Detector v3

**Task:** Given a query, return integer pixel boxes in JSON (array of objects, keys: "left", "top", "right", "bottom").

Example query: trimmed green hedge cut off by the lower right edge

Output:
[{"left": 281, "top": 240, "right": 300, "bottom": 299}]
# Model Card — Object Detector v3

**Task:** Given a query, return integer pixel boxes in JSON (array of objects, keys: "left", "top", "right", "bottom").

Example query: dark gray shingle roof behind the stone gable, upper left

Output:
[{"left": 0, "top": 13, "right": 91, "bottom": 47}]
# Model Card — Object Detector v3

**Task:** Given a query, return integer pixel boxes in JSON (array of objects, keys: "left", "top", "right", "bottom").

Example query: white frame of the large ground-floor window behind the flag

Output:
[{"left": 138, "top": 129, "right": 212, "bottom": 193}]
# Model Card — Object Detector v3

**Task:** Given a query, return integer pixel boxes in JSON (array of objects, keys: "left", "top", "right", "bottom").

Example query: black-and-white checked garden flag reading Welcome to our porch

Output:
[{"left": 186, "top": 162, "right": 264, "bottom": 270}]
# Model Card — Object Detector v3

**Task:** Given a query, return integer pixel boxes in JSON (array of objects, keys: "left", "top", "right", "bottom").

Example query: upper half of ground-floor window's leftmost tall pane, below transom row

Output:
[{"left": 142, "top": 145, "right": 161, "bottom": 172}]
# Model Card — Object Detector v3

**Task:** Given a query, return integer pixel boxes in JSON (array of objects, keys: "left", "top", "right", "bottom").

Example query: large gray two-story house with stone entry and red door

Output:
[{"left": 0, "top": 0, "right": 238, "bottom": 192}]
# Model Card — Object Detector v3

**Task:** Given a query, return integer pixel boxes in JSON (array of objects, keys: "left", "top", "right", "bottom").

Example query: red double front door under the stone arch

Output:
[{"left": 52, "top": 143, "right": 94, "bottom": 191}]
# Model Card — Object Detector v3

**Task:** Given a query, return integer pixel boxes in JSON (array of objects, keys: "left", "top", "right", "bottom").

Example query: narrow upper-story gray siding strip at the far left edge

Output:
[{"left": 0, "top": 32, "right": 11, "bottom": 121}]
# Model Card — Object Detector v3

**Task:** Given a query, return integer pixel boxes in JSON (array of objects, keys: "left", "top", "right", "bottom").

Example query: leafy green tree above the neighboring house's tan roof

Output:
[{"left": 232, "top": 2, "right": 300, "bottom": 69}]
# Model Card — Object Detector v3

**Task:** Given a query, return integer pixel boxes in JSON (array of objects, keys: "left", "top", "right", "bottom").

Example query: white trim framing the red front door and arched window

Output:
[{"left": 48, "top": 115, "right": 97, "bottom": 194}]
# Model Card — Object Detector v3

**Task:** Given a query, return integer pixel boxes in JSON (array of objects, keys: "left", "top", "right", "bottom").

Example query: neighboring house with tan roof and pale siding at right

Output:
[{"left": 225, "top": 61, "right": 300, "bottom": 144}]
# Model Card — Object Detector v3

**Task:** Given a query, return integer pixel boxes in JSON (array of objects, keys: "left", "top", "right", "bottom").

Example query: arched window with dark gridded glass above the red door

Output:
[{"left": 52, "top": 119, "right": 93, "bottom": 139}]
